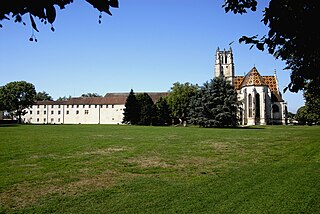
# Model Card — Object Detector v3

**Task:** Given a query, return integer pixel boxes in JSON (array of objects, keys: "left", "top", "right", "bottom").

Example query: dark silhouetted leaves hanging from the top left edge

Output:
[{"left": 0, "top": 0, "right": 119, "bottom": 41}]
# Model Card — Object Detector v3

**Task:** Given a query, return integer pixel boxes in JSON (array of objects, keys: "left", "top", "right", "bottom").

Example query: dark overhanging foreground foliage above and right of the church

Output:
[{"left": 223, "top": 0, "right": 320, "bottom": 93}]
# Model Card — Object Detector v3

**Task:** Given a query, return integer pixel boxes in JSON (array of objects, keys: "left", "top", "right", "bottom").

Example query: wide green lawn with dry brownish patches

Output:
[{"left": 0, "top": 125, "right": 320, "bottom": 214}]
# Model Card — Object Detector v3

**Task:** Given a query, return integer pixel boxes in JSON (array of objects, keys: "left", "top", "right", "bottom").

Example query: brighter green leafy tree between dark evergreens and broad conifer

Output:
[{"left": 167, "top": 82, "right": 198, "bottom": 123}]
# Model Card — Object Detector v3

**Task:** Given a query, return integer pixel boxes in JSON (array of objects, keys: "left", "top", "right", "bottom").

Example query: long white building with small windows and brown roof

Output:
[{"left": 22, "top": 92, "right": 168, "bottom": 124}]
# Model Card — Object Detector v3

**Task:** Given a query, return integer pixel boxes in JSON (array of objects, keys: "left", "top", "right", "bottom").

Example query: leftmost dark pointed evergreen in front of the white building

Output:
[{"left": 122, "top": 89, "right": 140, "bottom": 125}]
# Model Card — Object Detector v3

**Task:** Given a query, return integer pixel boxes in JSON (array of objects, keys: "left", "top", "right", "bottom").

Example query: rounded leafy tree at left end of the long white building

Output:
[{"left": 0, "top": 81, "right": 36, "bottom": 123}]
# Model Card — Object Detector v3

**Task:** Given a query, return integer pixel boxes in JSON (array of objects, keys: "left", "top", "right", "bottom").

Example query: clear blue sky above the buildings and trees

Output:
[{"left": 0, "top": 0, "right": 304, "bottom": 112}]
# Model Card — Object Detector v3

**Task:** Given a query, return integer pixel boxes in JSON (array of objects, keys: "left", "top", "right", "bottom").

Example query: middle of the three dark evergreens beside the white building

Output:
[{"left": 137, "top": 93, "right": 154, "bottom": 126}]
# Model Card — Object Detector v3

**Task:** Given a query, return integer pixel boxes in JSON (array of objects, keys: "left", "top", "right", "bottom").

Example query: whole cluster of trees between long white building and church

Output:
[{"left": 123, "top": 77, "right": 239, "bottom": 127}]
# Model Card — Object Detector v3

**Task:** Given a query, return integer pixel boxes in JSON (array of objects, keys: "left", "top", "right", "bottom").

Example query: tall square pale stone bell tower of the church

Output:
[{"left": 214, "top": 47, "right": 234, "bottom": 85}]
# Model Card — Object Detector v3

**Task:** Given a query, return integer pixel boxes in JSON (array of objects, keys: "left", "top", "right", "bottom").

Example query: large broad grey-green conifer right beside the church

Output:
[{"left": 189, "top": 77, "right": 239, "bottom": 127}]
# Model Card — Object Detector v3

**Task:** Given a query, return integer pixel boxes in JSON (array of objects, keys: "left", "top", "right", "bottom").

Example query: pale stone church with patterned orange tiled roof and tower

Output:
[{"left": 214, "top": 48, "right": 287, "bottom": 125}]
